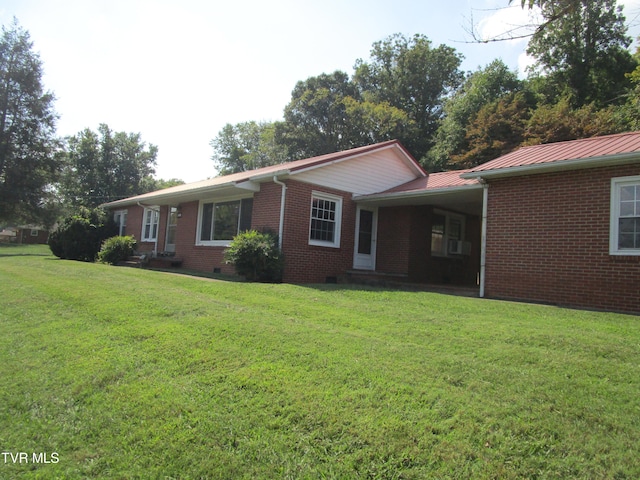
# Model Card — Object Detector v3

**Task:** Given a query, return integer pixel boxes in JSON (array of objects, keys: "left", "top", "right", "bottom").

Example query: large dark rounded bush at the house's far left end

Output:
[{"left": 48, "top": 208, "right": 118, "bottom": 262}]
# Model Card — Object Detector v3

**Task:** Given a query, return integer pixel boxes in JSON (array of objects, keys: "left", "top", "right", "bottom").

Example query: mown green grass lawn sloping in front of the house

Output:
[{"left": 0, "top": 247, "right": 640, "bottom": 479}]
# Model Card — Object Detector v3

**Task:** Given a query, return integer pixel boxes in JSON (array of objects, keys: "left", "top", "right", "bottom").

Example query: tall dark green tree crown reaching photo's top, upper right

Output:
[{"left": 527, "top": 0, "right": 636, "bottom": 108}]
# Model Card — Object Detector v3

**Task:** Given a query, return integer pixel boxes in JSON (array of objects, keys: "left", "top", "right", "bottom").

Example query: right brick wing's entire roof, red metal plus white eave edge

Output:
[{"left": 462, "top": 132, "right": 640, "bottom": 179}]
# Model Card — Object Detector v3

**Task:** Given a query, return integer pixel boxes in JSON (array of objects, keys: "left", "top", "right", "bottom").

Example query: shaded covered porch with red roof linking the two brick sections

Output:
[{"left": 348, "top": 172, "right": 483, "bottom": 296}]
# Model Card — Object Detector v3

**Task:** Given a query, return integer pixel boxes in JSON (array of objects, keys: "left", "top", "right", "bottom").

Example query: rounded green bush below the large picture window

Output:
[{"left": 224, "top": 230, "right": 284, "bottom": 282}]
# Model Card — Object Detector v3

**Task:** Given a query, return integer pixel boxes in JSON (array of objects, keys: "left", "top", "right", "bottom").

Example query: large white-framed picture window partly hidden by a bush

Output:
[{"left": 197, "top": 198, "right": 253, "bottom": 246}]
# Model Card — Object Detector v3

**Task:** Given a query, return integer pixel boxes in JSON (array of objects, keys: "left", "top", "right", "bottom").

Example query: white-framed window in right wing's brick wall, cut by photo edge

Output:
[{"left": 609, "top": 176, "right": 640, "bottom": 255}]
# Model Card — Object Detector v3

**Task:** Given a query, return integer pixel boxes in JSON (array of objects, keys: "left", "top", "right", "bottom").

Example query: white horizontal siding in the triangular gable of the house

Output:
[{"left": 293, "top": 150, "right": 418, "bottom": 195}]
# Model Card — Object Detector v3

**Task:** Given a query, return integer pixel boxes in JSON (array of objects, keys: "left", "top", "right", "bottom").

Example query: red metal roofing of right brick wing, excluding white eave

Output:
[{"left": 469, "top": 132, "right": 640, "bottom": 173}]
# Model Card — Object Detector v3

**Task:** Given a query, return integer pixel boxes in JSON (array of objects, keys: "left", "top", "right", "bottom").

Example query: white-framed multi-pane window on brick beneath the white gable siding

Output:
[{"left": 309, "top": 192, "right": 342, "bottom": 248}]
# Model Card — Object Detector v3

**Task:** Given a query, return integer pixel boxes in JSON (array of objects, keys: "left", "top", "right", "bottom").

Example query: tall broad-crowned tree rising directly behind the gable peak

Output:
[{"left": 354, "top": 34, "right": 463, "bottom": 158}]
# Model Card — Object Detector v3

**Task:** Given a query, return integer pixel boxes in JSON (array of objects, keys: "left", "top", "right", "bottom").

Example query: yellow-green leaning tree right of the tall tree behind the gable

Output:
[{"left": 423, "top": 60, "right": 523, "bottom": 172}]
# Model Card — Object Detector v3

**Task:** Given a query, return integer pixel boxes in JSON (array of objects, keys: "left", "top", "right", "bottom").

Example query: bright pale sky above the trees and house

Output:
[{"left": 0, "top": 0, "right": 640, "bottom": 182}]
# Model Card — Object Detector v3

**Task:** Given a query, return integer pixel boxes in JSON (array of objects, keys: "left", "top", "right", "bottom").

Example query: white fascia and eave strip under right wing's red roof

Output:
[{"left": 460, "top": 152, "right": 640, "bottom": 179}]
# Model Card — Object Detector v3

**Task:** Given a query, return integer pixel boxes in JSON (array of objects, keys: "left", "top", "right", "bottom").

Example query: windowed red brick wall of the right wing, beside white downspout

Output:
[{"left": 485, "top": 165, "right": 640, "bottom": 313}]
